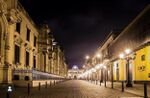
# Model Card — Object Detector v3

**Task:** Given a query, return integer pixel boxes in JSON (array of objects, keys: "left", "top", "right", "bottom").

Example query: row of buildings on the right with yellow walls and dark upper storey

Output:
[{"left": 84, "top": 5, "right": 150, "bottom": 87}]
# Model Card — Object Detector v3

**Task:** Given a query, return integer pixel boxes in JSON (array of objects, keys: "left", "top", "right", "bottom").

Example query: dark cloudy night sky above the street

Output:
[{"left": 20, "top": 0, "right": 149, "bottom": 67}]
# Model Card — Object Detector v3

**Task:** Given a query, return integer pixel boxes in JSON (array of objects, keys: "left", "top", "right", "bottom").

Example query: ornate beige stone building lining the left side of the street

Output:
[{"left": 0, "top": 0, "right": 67, "bottom": 83}]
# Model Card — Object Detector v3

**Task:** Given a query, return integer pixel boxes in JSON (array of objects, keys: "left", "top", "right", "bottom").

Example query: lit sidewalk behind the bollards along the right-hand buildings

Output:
[{"left": 86, "top": 81, "right": 150, "bottom": 98}]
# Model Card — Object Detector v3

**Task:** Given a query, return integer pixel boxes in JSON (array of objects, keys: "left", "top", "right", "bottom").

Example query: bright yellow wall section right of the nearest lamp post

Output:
[{"left": 134, "top": 46, "right": 150, "bottom": 81}]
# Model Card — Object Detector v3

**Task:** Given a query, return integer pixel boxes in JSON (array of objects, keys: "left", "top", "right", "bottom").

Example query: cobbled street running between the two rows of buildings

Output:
[{"left": 3, "top": 80, "right": 141, "bottom": 98}]
